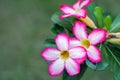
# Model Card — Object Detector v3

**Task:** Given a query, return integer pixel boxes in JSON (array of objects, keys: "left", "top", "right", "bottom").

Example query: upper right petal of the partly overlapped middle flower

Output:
[{"left": 88, "top": 28, "right": 107, "bottom": 45}]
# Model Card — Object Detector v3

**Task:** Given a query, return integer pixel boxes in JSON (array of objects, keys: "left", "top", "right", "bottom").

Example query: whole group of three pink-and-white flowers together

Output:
[{"left": 41, "top": 0, "right": 107, "bottom": 76}]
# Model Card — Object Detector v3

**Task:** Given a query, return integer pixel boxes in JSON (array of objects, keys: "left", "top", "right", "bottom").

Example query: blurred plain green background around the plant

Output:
[{"left": 0, "top": 0, "right": 120, "bottom": 80}]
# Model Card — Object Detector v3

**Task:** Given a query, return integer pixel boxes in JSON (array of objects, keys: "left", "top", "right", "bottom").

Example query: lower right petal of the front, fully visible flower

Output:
[{"left": 65, "top": 58, "right": 80, "bottom": 76}]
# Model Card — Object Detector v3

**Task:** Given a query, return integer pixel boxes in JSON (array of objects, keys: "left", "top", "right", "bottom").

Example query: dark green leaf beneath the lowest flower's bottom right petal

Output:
[{"left": 62, "top": 64, "right": 87, "bottom": 80}]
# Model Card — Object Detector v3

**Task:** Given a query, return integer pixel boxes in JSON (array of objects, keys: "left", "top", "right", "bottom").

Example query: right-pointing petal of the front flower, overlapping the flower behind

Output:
[{"left": 69, "top": 46, "right": 86, "bottom": 59}]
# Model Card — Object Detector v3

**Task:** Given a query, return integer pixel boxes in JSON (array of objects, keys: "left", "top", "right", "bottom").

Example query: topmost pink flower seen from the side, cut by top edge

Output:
[{"left": 60, "top": 0, "right": 91, "bottom": 19}]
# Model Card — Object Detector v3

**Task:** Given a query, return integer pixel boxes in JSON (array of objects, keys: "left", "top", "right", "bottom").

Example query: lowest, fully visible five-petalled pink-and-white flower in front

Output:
[{"left": 42, "top": 34, "right": 86, "bottom": 76}]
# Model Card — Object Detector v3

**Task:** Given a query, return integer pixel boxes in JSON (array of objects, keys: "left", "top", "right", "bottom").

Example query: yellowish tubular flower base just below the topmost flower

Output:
[{"left": 80, "top": 16, "right": 97, "bottom": 29}]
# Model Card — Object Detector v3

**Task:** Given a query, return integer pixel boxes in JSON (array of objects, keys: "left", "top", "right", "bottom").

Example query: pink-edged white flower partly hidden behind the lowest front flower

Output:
[{"left": 70, "top": 21, "right": 107, "bottom": 63}]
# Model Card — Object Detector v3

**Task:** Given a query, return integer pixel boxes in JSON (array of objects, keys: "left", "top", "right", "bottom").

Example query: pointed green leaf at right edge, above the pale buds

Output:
[{"left": 109, "top": 15, "right": 120, "bottom": 32}]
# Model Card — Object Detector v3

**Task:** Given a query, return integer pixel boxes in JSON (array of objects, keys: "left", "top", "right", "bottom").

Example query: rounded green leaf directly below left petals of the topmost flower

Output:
[{"left": 51, "top": 12, "right": 72, "bottom": 31}]
